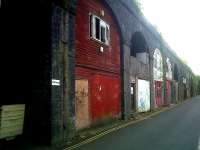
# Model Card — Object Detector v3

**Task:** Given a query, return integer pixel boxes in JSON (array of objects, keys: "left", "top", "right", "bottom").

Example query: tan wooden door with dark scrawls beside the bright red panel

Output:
[{"left": 75, "top": 79, "right": 90, "bottom": 130}]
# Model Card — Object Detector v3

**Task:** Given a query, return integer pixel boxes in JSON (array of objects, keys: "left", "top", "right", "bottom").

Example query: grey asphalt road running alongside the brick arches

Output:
[{"left": 78, "top": 97, "right": 200, "bottom": 150}]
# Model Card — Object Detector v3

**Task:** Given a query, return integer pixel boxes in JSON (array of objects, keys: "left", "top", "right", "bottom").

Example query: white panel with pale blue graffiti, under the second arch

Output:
[{"left": 137, "top": 80, "right": 150, "bottom": 112}]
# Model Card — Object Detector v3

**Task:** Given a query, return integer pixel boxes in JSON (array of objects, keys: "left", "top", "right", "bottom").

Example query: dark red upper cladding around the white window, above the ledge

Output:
[{"left": 75, "top": 0, "right": 120, "bottom": 73}]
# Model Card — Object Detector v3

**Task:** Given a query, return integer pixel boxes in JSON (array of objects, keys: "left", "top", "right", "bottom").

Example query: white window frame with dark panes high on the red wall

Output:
[{"left": 89, "top": 13, "right": 110, "bottom": 45}]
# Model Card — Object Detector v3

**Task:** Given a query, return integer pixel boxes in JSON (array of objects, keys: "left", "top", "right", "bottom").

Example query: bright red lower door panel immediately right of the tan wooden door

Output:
[{"left": 90, "top": 75, "right": 120, "bottom": 121}]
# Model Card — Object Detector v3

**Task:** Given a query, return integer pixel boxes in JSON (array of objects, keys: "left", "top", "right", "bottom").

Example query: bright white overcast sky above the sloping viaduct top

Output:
[{"left": 141, "top": 0, "right": 200, "bottom": 75}]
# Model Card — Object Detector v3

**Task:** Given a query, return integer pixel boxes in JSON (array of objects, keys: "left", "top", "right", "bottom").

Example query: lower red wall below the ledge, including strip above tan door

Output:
[{"left": 76, "top": 67, "right": 121, "bottom": 122}]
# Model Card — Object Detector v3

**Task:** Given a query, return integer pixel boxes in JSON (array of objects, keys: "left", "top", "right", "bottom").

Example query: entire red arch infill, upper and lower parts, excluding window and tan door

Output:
[{"left": 75, "top": 0, "right": 121, "bottom": 122}]
